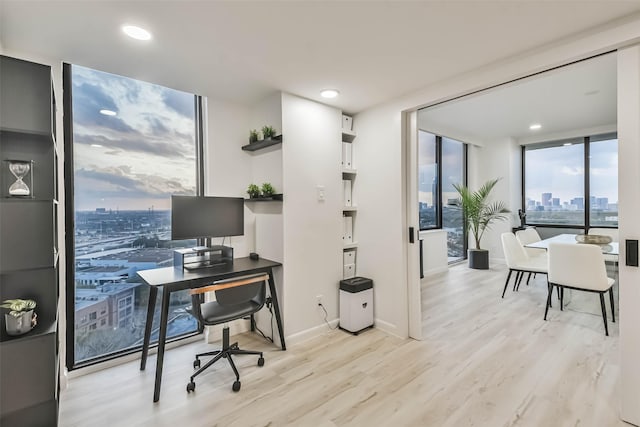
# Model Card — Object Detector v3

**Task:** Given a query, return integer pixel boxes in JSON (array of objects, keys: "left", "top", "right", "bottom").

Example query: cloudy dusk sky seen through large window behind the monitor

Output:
[{"left": 72, "top": 65, "right": 196, "bottom": 210}]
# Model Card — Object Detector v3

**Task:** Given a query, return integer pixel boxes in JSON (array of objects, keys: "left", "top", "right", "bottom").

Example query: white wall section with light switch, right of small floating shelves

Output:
[{"left": 282, "top": 94, "right": 340, "bottom": 341}]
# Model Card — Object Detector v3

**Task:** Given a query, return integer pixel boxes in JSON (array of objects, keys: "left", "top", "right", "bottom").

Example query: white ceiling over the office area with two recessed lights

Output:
[{"left": 0, "top": 0, "right": 640, "bottom": 113}]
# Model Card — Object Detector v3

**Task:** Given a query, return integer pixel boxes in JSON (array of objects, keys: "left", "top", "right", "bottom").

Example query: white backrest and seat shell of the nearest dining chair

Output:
[{"left": 548, "top": 243, "right": 609, "bottom": 291}]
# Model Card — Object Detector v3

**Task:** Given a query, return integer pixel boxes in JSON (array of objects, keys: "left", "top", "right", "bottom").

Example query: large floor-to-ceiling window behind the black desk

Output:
[{"left": 64, "top": 64, "right": 202, "bottom": 368}]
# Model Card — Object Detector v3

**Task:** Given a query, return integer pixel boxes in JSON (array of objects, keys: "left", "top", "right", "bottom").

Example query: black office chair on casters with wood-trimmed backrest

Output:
[{"left": 187, "top": 274, "right": 269, "bottom": 392}]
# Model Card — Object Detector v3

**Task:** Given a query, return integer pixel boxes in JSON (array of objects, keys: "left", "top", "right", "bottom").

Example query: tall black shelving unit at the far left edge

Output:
[{"left": 0, "top": 56, "right": 59, "bottom": 427}]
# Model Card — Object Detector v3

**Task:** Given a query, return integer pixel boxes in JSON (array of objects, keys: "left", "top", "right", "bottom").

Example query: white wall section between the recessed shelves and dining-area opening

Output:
[{"left": 353, "top": 104, "right": 408, "bottom": 337}]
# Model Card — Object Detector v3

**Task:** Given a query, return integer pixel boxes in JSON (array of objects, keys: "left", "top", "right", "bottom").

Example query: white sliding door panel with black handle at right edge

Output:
[{"left": 618, "top": 45, "right": 640, "bottom": 425}]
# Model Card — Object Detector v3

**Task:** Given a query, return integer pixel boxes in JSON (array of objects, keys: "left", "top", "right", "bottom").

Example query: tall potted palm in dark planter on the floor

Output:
[{"left": 453, "top": 178, "right": 511, "bottom": 270}]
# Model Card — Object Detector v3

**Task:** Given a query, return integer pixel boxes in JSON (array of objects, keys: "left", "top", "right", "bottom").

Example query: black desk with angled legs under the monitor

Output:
[{"left": 138, "top": 258, "right": 287, "bottom": 402}]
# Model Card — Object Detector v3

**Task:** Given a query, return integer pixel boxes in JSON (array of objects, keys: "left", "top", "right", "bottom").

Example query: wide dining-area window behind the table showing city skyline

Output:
[{"left": 523, "top": 135, "right": 618, "bottom": 228}]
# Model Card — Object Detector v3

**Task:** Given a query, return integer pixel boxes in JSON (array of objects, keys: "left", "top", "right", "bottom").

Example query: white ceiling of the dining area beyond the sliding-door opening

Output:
[{"left": 418, "top": 53, "right": 617, "bottom": 145}]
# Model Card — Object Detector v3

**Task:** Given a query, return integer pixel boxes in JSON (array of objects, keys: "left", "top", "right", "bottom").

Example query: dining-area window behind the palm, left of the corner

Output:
[{"left": 418, "top": 130, "right": 466, "bottom": 262}]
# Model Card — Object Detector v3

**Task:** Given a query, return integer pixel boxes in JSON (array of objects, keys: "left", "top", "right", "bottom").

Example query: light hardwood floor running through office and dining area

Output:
[{"left": 60, "top": 265, "right": 628, "bottom": 427}]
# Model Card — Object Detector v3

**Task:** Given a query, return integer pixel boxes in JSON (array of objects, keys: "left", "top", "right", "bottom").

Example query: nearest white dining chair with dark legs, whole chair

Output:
[{"left": 544, "top": 243, "right": 616, "bottom": 336}]
